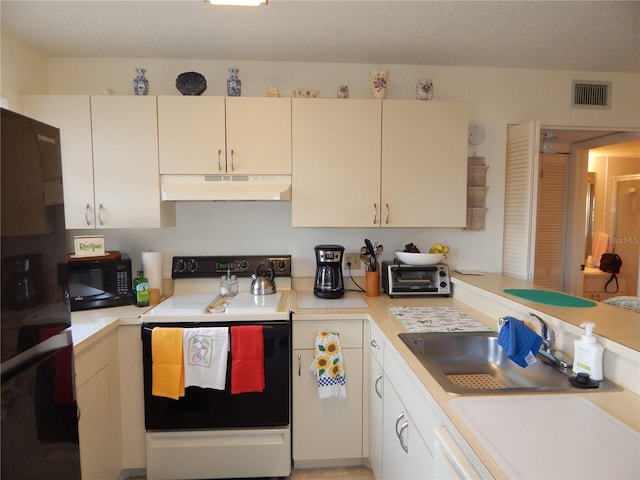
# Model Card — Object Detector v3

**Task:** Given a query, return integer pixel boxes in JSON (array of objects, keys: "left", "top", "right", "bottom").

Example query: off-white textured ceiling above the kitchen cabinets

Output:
[{"left": 0, "top": 0, "right": 640, "bottom": 72}]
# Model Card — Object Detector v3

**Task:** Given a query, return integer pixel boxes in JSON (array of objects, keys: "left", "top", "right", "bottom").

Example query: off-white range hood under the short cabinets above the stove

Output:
[{"left": 160, "top": 175, "right": 291, "bottom": 201}]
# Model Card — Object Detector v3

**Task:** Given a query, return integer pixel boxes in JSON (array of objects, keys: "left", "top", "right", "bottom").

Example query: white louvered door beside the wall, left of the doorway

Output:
[{"left": 502, "top": 121, "right": 540, "bottom": 281}]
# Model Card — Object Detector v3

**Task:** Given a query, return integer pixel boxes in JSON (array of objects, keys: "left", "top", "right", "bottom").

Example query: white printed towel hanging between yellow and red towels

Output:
[{"left": 182, "top": 327, "right": 229, "bottom": 390}]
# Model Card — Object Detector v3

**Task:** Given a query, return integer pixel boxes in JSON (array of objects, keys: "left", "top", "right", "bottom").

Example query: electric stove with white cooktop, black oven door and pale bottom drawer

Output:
[{"left": 141, "top": 255, "right": 291, "bottom": 480}]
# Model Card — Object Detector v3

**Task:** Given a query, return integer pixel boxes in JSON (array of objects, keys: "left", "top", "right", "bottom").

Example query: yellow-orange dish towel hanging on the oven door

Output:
[{"left": 151, "top": 327, "right": 184, "bottom": 400}]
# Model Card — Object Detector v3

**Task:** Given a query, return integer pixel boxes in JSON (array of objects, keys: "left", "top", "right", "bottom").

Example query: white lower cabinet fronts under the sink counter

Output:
[{"left": 369, "top": 322, "right": 492, "bottom": 480}]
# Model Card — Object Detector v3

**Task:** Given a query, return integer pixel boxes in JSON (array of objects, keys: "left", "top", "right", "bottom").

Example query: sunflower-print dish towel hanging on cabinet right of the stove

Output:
[{"left": 309, "top": 330, "right": 347, "bottom": 400}]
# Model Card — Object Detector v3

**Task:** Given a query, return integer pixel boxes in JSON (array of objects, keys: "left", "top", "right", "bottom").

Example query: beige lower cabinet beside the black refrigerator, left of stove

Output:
[{"left": 74, "top": 330, "right": 122, "bottom": 480}]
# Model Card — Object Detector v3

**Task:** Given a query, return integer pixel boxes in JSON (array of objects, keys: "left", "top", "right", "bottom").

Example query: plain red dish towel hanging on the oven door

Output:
[{"left": 231, "top": 325, "right": 264, "bottom": 394}]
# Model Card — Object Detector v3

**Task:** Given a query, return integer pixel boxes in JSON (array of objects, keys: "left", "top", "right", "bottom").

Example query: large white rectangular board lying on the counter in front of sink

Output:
[{"left": 450, "top": 395, "right": 640, "bottom": 480}]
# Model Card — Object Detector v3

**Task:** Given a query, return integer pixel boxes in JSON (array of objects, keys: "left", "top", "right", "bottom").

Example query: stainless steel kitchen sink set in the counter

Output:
[{"left": 398, "top": 332, "right": 619, "bottom": 395}]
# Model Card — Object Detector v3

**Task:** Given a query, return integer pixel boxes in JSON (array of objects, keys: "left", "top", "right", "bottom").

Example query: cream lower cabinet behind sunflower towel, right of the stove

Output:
[{"left": 292, "top": 320, "right": 363, "bottom": 468}]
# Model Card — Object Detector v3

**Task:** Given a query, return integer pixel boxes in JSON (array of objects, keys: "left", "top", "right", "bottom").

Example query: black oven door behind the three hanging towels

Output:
[{"left": 142, "top": 320, "right": 291, "bottom": 431}]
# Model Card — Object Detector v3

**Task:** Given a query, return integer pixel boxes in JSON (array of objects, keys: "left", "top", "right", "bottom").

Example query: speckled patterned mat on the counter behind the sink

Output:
[{"left": 389, "top": 307, "right": 493, "bottom": 333}]
